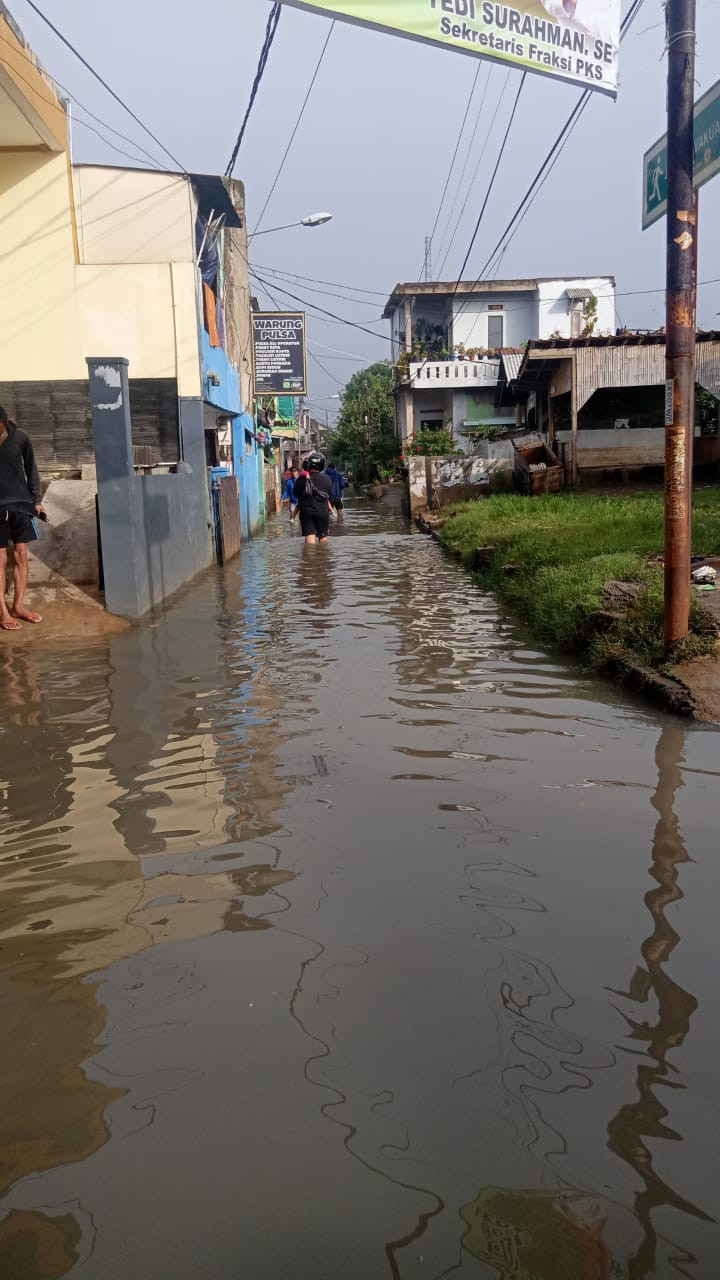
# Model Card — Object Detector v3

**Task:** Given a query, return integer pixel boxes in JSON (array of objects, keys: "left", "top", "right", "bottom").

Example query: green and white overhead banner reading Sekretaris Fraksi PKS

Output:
[{"left": 284, "top": 0, "right": 620, "bottom": 97}]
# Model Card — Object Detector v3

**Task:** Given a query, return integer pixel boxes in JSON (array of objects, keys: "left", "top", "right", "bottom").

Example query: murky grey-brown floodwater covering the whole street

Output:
[{"left": 0, "top": 502, "right": 720, "bottom": 1280}]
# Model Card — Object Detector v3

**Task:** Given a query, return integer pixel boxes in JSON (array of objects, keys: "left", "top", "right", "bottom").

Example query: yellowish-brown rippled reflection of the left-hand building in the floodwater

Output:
[{"left": 0, "top": 573, "right": 292, "bottom": 1280}]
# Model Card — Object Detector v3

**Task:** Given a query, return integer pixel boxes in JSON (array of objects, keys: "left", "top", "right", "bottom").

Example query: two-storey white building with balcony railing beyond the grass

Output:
[{"left": 383, "top": 275, "right": 615, "bottom": 452}]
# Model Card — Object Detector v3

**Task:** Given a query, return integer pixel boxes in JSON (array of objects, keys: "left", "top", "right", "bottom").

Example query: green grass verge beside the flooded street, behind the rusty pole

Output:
[{"left": 441, "top": 486, "right": 720, "bottom": 671}]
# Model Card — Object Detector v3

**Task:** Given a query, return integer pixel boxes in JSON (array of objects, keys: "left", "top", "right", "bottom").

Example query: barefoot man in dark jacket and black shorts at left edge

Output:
[{"left": 0, "top": 406, "right": 45, "bottom": 631}]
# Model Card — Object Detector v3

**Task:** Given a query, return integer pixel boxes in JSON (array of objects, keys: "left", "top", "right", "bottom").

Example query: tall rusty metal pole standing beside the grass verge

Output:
[{"left": 665, "top": 0, "right": 696, "bottom": 645}]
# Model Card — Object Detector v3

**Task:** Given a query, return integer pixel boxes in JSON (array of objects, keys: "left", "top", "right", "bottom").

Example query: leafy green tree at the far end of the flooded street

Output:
[{"left": 328, "top": 360, "right": 400, "bottom": 481}]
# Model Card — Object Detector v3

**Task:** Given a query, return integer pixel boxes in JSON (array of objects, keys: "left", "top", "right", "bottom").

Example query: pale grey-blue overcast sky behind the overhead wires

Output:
[{"left": 8, "top": 0, "right": 720, "bottom": 413}]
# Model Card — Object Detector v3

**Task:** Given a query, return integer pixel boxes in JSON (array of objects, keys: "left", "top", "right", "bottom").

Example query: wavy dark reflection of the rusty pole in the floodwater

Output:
[{"left": 607, "top": 726, "right": 711, "bottom": 1280}]
